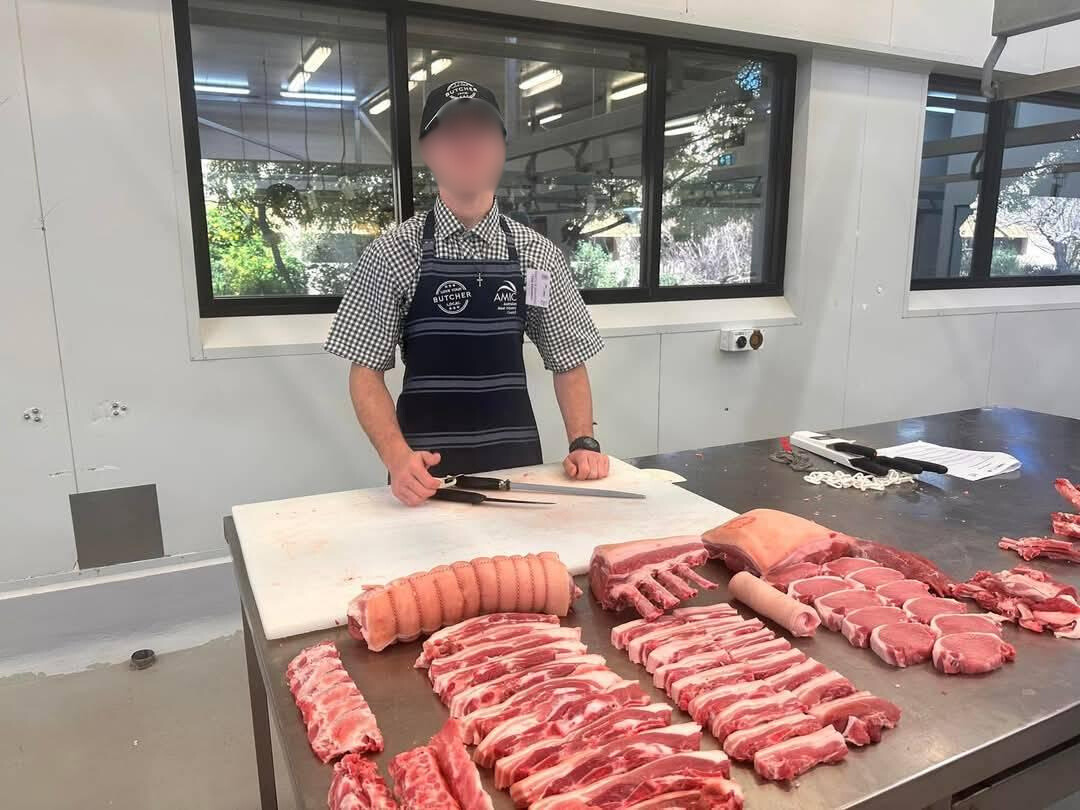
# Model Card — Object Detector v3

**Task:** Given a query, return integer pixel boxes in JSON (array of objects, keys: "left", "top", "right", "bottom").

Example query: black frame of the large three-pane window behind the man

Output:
[{"left": 173, "top": 0, "right": 797, "bottom": 318}]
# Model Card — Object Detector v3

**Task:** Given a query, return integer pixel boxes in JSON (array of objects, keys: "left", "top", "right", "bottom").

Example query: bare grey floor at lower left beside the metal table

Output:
[{"left": 0, "top": 634, "right": 1080, "bottom": 810}]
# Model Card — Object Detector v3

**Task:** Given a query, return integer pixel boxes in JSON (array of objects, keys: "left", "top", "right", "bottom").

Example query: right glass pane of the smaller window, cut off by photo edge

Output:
[{"left": 990, "top": 97, "right": 1080, "bottom": 276}]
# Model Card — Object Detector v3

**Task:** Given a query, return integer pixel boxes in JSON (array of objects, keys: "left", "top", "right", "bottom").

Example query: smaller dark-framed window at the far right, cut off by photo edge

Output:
[{"left": 912, "top": 77, "right": 1080, "bottom": 289}]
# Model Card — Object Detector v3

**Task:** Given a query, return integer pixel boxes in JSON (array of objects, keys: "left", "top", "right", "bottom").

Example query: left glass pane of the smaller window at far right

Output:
[{"left": 913, "top": 89, "right": 986, "bottom": 279}]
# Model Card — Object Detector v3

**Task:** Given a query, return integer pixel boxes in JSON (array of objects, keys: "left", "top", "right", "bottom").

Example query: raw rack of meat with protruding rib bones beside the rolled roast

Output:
[{"left": 589, "top": 536, "right": 716, "bottom": 619}]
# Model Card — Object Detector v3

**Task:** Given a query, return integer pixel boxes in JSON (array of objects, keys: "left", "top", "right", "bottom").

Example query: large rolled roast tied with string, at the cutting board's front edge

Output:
[{"left": 349, "top": 551, "right": 581, "bottom": 652}]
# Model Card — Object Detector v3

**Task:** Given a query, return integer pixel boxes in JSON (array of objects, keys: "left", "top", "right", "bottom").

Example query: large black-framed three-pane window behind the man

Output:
[{"left": 174, "top": 0, "right": 795, "bottom": 316}]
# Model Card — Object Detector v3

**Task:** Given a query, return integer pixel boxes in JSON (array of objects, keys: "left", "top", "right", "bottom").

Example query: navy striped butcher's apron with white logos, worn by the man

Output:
[{"left": 397, "top": 212, "right": 542, "bottom": 475}]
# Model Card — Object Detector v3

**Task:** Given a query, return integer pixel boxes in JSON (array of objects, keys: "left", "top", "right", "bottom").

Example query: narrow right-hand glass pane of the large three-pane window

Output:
[{"left": 660, "top": 51, "right": 775, "bottom": 286}]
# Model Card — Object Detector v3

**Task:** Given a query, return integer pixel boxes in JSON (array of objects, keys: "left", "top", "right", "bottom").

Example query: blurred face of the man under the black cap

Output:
[{"left": 420, "top": 105, "right": 507, "bottom": 194}]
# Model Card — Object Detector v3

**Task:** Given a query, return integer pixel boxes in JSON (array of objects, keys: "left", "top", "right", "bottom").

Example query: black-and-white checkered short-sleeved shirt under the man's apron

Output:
[{"left": 323, "top": 199, "right": 604, "bottom": 372}]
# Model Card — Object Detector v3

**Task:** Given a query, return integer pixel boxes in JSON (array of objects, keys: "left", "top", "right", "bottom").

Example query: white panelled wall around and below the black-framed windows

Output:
[{"left": 0, "top": 0, "right": 1080, "bottom": 581}]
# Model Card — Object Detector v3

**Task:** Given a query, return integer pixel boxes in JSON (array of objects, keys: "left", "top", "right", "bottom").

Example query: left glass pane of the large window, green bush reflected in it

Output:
[{"left": 190, "top": 0, "right": 394, "bottom": 297}]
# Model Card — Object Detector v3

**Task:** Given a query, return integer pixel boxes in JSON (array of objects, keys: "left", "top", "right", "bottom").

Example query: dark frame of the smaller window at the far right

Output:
[{"left": 910, "top": 73, "right": 1080, "bottom": 291}]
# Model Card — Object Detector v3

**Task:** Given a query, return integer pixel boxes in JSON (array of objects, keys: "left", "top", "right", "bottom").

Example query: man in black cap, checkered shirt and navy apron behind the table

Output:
[{"left": 325, "top": 81, "right": 608, "bottom": 505}]
